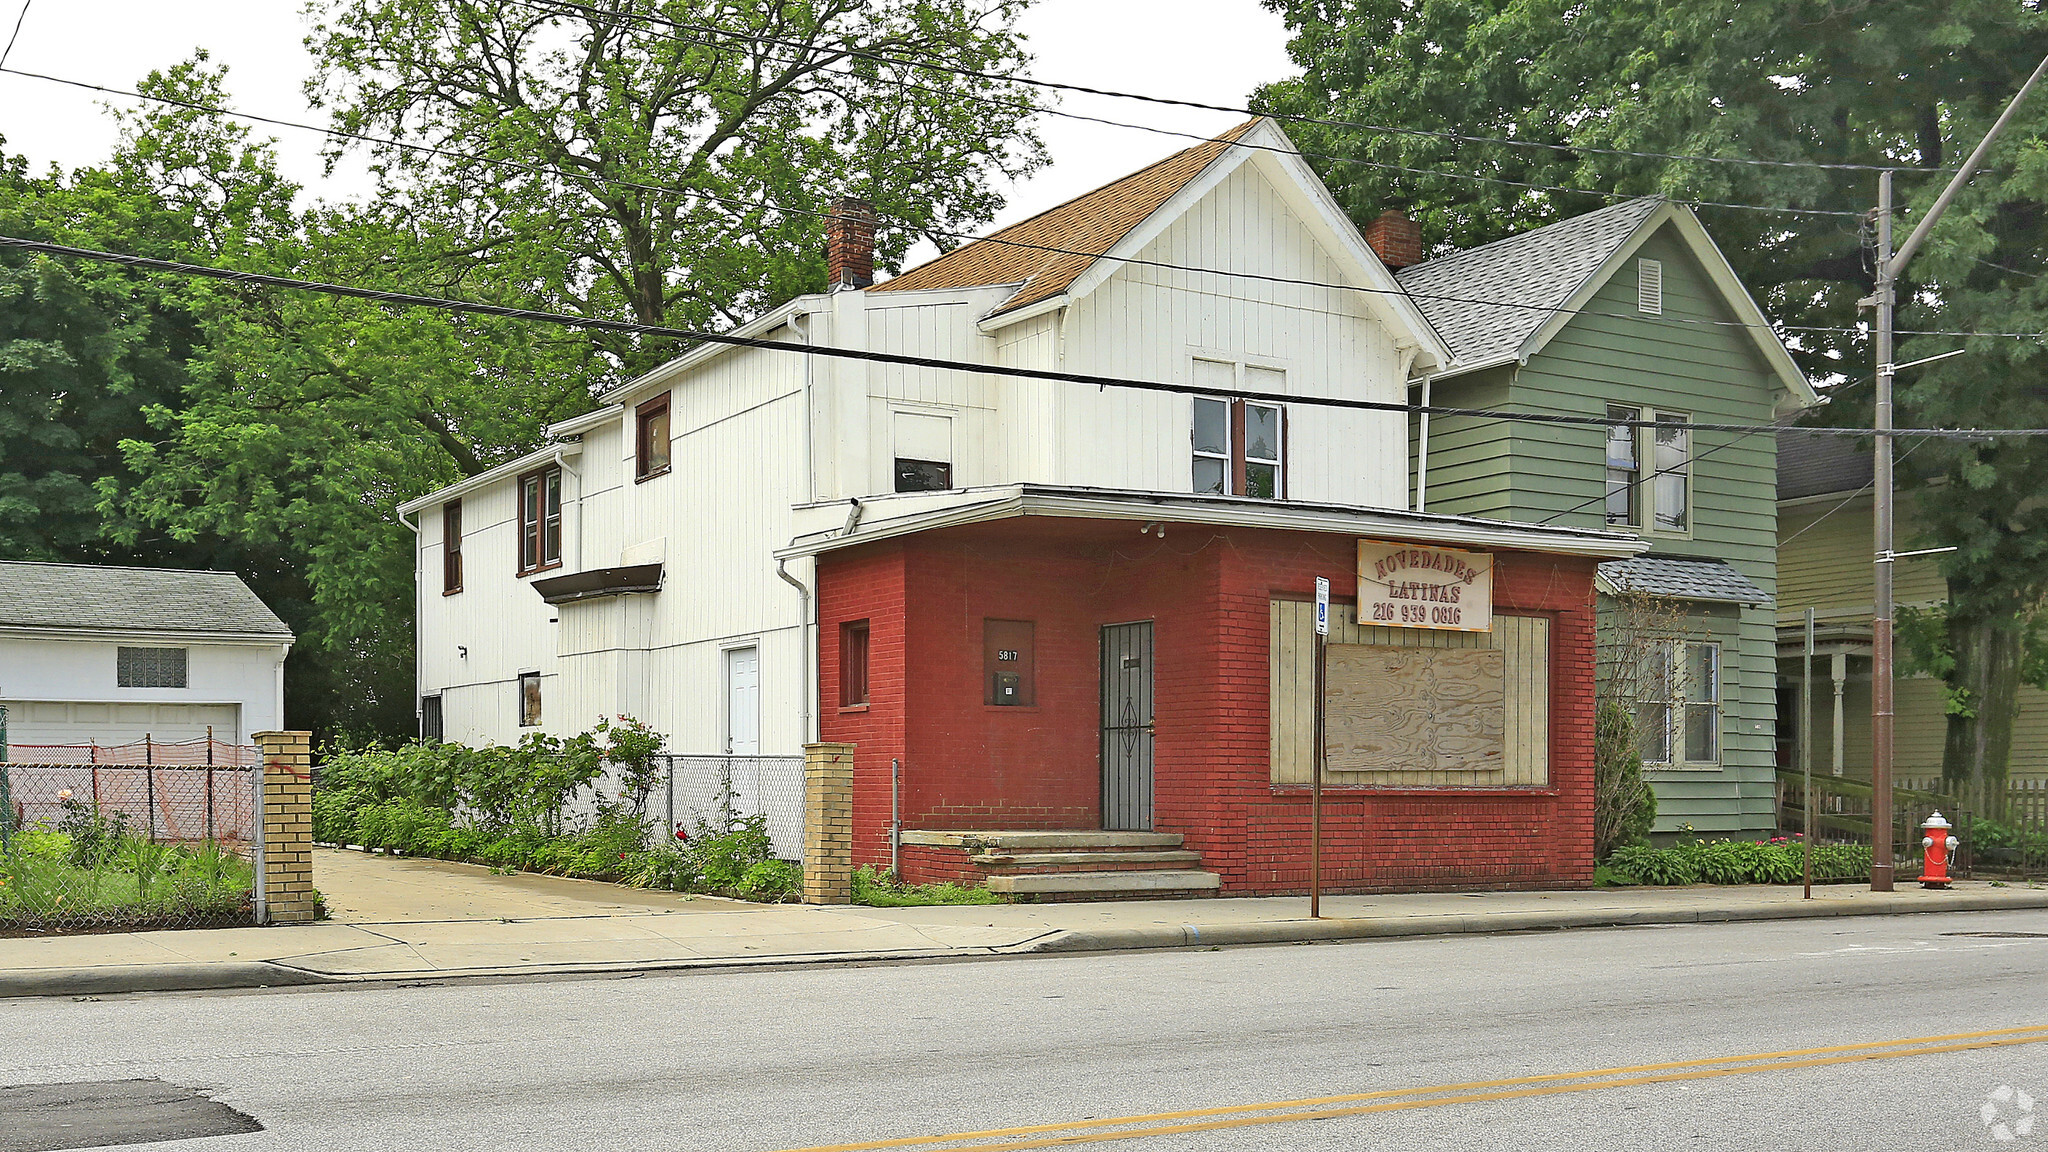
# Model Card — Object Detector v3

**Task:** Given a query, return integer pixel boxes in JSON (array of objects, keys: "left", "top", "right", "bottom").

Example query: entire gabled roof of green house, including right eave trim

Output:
[{"left": 1395, "top": 197, "right": 1819, "bottom": 406}]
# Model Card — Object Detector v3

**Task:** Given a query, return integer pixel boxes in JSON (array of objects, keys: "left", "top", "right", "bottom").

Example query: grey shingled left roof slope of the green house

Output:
[{"left": 1395, "top": 197, "right": 1665, "bottom": 365}]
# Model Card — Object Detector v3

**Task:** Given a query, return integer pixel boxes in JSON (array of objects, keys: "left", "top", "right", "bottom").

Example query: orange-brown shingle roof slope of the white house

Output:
[{"left": 868, "top": 119, "right": 1260, "bottom": 314}]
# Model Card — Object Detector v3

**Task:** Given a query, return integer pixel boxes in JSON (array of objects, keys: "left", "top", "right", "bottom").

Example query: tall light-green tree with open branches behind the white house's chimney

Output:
[{"left": 309, "top": 0, "right": 1042, "bottom": 373}]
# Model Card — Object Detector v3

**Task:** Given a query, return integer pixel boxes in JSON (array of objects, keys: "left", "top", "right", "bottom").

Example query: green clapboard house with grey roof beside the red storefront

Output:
[{"left": 1399, "top": 197, "right": 1815, "bottom": 836}]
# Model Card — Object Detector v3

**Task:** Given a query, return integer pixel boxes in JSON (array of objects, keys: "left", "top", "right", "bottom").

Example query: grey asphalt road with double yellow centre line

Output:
[{"left": 0, "top": 912, "right": 2048, "bottom": 1152}]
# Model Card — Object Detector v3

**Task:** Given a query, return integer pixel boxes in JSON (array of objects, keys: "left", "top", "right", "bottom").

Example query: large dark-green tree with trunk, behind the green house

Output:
[{"left": 1255, "top": 0, "right": 2048, "bottom": 779}]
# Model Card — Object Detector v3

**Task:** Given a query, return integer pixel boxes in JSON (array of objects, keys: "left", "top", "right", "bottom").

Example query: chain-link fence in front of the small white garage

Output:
[{"left": 0, "top": 748, "right": 262, "bottom": 935}]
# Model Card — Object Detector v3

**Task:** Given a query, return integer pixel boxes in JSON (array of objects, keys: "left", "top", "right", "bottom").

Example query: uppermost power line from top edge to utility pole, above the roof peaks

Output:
[{"left": 514, "top": 0, "right": 1952, "bottom": 175}]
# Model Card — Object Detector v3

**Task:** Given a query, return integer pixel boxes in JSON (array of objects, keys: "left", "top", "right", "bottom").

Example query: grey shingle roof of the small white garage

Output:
[{"left": 0, "top": 560, "right": 291, "bottom": 640}]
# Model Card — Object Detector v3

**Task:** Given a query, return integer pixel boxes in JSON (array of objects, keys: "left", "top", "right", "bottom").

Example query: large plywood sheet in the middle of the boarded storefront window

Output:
[{"left": 1325, "top": 644, "right": 1507, "bottom": 773}]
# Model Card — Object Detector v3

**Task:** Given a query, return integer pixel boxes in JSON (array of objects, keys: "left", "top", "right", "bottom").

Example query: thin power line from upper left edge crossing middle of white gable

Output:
[{"left": 16, "top": 68, "right": 2048, "bottom": 340}]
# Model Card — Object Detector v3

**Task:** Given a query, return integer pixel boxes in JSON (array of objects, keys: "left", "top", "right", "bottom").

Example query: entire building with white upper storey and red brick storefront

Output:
[{"left": 399, "top": 119, "right": 1642, "bottom": 894}]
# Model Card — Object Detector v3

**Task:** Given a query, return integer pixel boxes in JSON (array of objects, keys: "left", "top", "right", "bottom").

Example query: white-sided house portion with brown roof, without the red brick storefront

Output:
[{"left": 399, "top": 119, "right": 1448, "bottom": 752}]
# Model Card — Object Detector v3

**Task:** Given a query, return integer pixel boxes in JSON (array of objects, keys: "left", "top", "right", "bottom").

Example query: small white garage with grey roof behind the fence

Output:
[{"left": 0, "top": 562, "right": 293, "bottom": 754}]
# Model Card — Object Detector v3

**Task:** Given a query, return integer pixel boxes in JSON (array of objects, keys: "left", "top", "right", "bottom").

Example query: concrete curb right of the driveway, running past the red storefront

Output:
[{"left": 1030, "top": 892, "right": 2048, "bottom": 953}]
